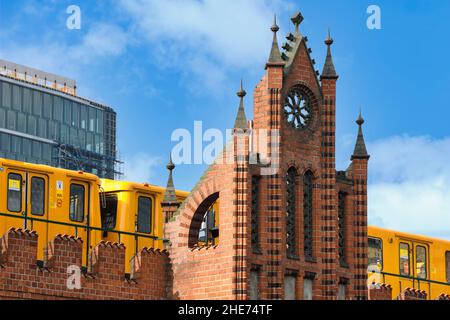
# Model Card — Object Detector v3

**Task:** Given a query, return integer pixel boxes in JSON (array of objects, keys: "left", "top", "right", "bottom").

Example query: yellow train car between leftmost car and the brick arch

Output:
[{"left": 100, "top": 179, "right": 189, "bottom": 273}]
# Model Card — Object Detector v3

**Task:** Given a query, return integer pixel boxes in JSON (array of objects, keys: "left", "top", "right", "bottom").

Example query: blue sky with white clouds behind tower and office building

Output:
[{"left": 0, "top": 0, "right": 450, "bottom": 238}]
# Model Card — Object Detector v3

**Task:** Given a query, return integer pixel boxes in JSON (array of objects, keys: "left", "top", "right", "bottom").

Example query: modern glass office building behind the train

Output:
[{"left": 0, "top": 60, "right": 119, "bottom": 178}]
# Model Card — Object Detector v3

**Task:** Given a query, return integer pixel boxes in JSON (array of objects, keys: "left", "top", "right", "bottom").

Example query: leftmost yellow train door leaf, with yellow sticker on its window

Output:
[{"left": 1, "top": 170, "right": 27, "bottom": 235}]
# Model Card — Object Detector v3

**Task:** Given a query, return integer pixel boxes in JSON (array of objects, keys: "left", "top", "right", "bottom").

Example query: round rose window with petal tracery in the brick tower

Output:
[{"left": 284, "top": 87, "right": 312, "bottom": 129}]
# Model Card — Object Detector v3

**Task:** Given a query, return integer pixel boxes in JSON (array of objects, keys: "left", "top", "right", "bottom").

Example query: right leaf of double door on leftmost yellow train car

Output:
[{"left": 26, "top": 173, "right": 49, "bottom": 261}]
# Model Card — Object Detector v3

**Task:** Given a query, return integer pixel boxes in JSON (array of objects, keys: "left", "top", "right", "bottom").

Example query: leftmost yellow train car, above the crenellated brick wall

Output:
[{"left": 0, "top": 159, "right": 101, "bottom": 266}]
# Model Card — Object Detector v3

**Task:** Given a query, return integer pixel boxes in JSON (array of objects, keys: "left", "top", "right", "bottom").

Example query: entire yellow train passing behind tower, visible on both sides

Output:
[{"left": 0, "top": 159, "right": 450, "bottom": 298}]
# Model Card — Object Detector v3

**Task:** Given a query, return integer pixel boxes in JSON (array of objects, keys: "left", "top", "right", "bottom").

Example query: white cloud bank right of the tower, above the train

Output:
[{"left": 368, "top": 136, "right": 450, "bottom": 239}]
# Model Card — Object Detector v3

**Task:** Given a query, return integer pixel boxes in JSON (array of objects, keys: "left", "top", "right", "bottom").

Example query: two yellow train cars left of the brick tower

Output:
[{"left": 0, "top": 159, "right": 188, "bottom": 273}]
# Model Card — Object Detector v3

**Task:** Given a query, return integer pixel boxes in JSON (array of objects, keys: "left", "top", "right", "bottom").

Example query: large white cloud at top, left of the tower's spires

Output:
[{"left": 120, "top": 0, "right": 292, "bottom": 93}]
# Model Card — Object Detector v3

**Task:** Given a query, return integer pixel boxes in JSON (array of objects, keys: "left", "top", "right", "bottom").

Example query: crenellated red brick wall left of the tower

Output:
[{"left": 0, "top": 228, "right": 170, "bottom": 300}]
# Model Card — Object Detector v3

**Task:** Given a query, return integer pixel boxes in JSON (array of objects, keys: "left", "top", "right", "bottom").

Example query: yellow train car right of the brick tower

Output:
[{"left": 368, "top": 227, "right": 450, "bottom": 299}]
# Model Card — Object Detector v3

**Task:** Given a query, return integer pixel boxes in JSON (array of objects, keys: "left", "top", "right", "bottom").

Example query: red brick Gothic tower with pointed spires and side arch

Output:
[{"left": 166, "top": 13, "right": 369, "bottom": 299}]
